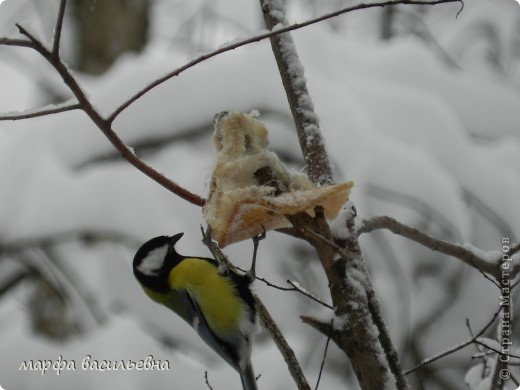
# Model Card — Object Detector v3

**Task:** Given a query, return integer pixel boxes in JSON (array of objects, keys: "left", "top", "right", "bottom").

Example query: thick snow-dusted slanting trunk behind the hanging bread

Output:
[{"left": 260, "top": 0, "right": 418, "bottom": 390}]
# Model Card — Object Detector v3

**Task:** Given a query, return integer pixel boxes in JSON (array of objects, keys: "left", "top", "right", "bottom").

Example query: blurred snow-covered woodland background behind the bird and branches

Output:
[{"left": 0, "top": 0, "right": 520, "bottom": 390}]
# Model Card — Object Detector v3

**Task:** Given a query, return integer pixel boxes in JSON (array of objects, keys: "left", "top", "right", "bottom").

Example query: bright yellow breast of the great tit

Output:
[{"left": 168, "top": 258, "right": 245, "bottom": 333}]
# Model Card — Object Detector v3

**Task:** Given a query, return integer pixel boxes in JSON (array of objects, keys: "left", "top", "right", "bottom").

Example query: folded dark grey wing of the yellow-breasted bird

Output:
[{"left": 169, "top": 290, "right": 240, "bottom": 371}]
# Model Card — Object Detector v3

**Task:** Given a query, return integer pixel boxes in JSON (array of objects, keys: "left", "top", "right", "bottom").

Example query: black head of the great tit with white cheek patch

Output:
[{"left": 133, "top": 233, "right": 184, "bottom": 292}]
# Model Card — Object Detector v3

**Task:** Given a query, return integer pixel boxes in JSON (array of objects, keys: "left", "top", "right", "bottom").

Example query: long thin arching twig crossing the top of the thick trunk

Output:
[{"left": 107, "top": 0, "right": 464, "bottom": 122}]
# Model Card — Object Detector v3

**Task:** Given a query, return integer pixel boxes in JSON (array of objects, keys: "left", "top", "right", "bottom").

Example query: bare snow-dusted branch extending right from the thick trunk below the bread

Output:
[{"left": 358, "top": 216, "right": 520, "bottom": 280}]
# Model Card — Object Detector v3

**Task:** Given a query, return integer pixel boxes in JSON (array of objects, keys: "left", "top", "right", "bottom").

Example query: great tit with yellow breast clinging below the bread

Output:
[{"left": 133, "top": 233, "right": 258, "bottom": 390}]
